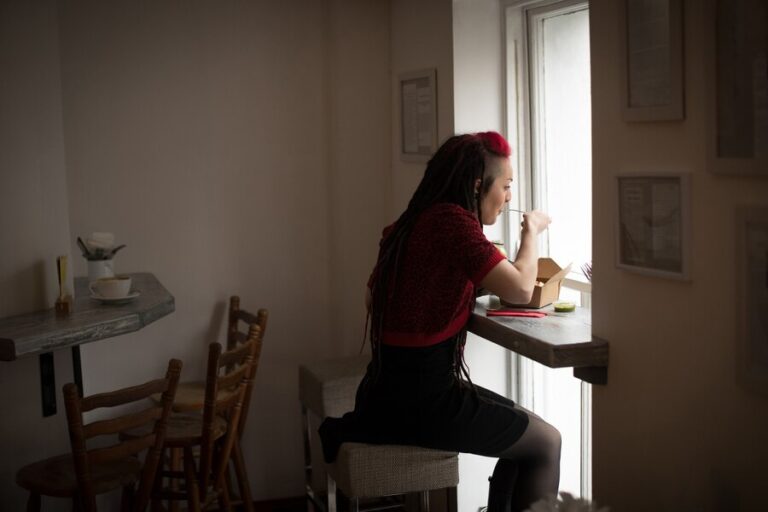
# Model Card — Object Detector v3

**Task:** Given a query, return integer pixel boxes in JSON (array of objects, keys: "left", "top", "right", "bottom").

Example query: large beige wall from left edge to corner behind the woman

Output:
[{"left": 0, "top": 0, "right": 390, "bottom": 510}]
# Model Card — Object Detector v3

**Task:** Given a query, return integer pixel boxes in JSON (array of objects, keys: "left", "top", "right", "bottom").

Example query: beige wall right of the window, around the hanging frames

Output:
[{"left": 590, "top": 0, "right": 768, "bottom": 512}]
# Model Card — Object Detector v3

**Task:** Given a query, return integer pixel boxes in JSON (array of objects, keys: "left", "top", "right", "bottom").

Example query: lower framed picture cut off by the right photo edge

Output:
[{"left": 736, "top": 207, "right": 768, "bottom": 395}]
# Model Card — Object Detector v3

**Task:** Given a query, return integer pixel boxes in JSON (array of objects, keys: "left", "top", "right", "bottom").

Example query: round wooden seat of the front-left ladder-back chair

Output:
[{"left": 16, "top": 453, "right": 142, "bottom": 498}]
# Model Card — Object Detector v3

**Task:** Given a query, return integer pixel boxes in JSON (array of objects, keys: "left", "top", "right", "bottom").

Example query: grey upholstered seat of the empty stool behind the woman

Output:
[{"left": 299, "top": 355, "right": 371, "bottom": 418}]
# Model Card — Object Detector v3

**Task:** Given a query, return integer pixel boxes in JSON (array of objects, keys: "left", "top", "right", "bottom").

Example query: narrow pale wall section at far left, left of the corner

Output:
[{"left": 0, "top": 2, "right": 72, "bottom": 510}]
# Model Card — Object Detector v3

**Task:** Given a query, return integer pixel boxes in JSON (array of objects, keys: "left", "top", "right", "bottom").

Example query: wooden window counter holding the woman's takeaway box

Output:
[{"left": 468, "top": 296, "right": 608, "bottom": 384}]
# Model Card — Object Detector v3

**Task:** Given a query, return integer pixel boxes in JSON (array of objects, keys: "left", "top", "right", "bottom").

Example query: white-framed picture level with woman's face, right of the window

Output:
[{"left": 616, "top": 173, "right": 691, "bottom": 280}]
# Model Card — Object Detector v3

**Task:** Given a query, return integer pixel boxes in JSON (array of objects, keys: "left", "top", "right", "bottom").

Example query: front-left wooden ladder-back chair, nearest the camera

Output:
[{"left": 16, "top": 359, "right": 181, "bottom": 512}]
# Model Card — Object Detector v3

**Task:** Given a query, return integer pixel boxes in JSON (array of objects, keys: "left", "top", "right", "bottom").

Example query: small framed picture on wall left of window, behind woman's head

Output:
[{"left": 399, "top": 69, "right": 437, "bottom": 162}]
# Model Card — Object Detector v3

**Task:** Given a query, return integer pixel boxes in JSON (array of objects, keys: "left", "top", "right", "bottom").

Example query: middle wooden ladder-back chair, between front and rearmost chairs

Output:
[{"left": 130, "top": 324, "right": 261, "bottom": 511}]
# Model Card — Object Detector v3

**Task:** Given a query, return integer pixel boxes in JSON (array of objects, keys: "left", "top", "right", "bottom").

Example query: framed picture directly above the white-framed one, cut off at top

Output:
[{"left": 620, "top": 0, "right": 685, "bottom": 121}]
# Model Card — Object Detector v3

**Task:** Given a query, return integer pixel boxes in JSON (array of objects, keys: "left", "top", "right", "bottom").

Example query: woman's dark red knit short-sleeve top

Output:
[{"left": 369, "top": 203, "right": 504, "bottom": 347}]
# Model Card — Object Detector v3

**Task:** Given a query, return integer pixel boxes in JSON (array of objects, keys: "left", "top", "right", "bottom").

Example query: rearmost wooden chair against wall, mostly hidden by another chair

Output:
[{"left": 157, "top": 295, "right": 269, "bottom": 512}]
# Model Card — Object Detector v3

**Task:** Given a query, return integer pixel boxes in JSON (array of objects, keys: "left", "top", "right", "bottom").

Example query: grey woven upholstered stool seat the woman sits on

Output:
[{"left": 327, "top": 443, "right": 459, "bottom": 498}]
